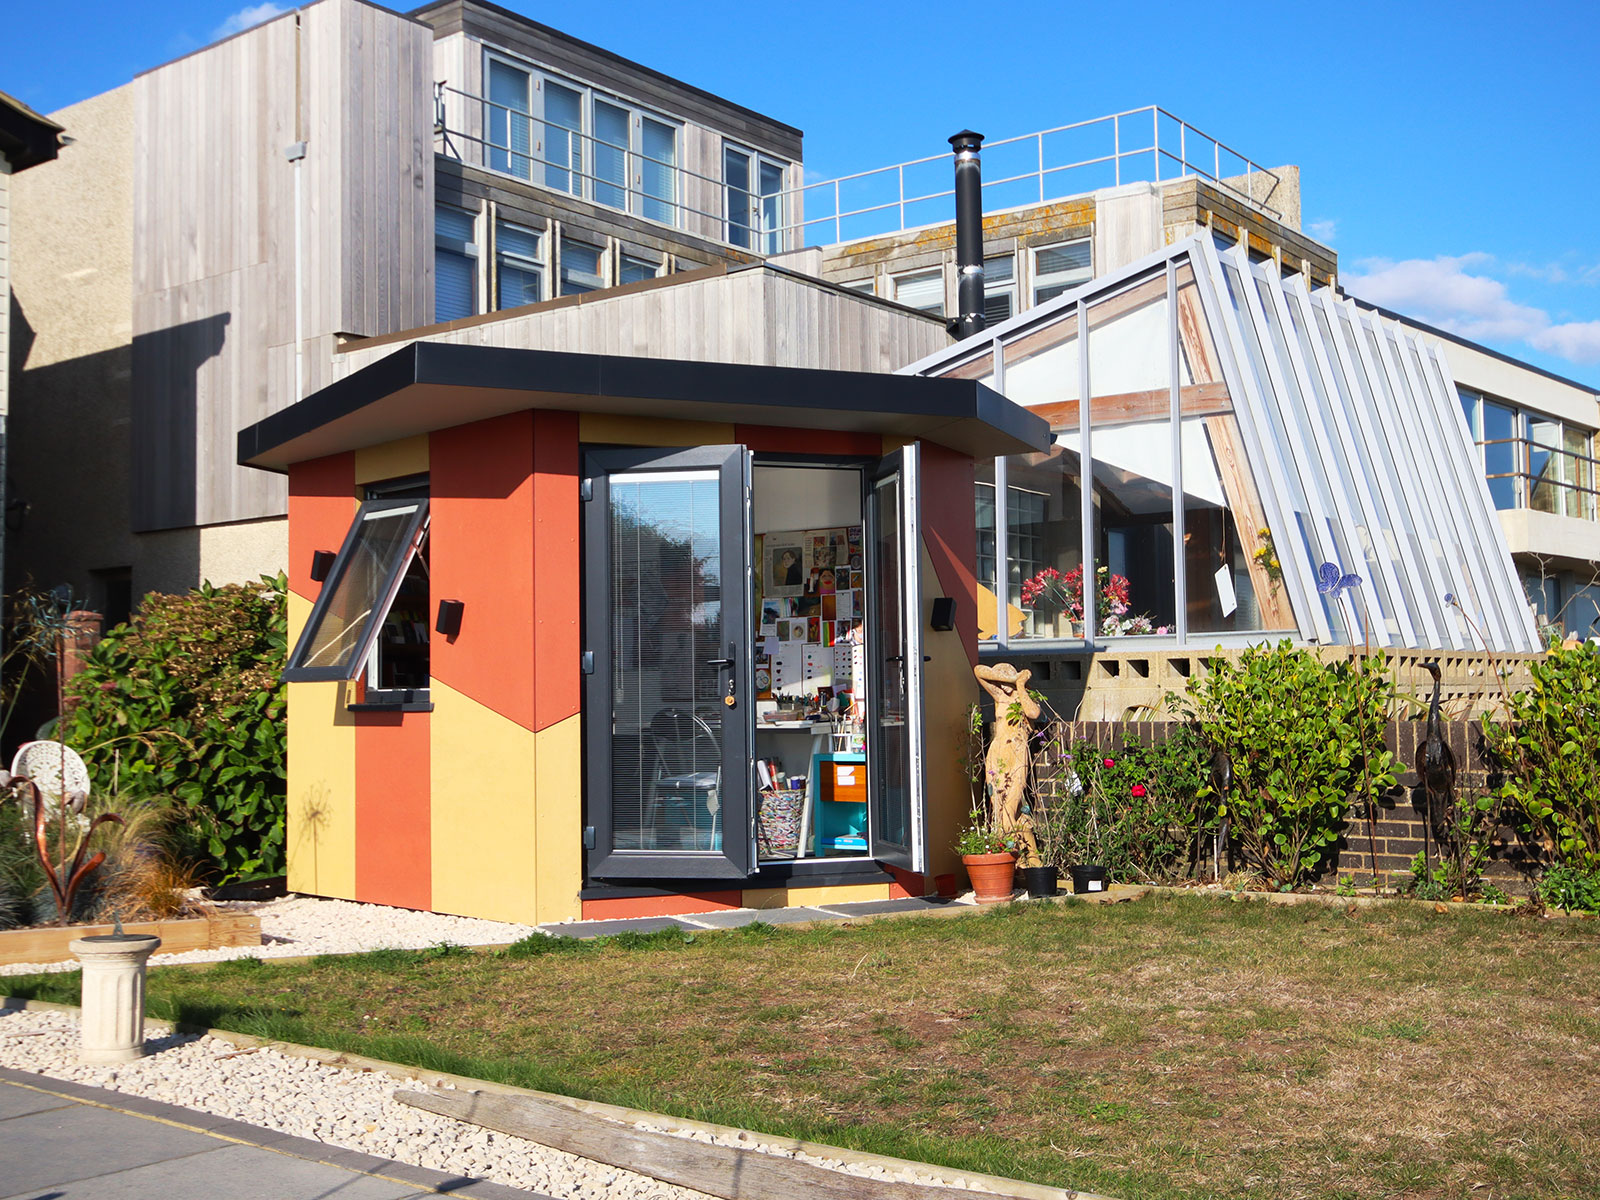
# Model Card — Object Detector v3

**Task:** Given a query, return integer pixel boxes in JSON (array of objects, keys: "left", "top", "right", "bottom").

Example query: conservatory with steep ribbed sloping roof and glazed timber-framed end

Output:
[{"left": 904, "top": 234, "right": 1538, "bottom": 651}]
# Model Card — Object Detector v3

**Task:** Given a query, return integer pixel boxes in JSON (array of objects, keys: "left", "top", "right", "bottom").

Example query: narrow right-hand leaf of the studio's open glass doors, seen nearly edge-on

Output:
[{"left": 866, "top": 443, "right": 928, "bottom": 870}]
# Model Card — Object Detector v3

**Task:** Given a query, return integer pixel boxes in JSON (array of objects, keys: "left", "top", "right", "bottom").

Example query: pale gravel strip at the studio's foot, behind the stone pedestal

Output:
[{"left": 0, "top": 896, "right": 544, "bottom": 976}]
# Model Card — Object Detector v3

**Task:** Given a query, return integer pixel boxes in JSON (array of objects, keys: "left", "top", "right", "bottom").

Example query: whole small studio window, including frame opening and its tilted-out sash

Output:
[{"left": 283, "top": 485, "right": 429, "bottom": 701}]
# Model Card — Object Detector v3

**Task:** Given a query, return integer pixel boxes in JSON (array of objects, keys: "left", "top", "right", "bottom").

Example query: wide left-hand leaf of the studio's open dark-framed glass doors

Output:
[{"left": 584, "top": 446, "right": 755, "bottom": 880}]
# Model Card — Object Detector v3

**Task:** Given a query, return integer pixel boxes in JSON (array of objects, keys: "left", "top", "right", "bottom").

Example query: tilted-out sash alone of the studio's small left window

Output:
[{"left": 283, "top": 498, "right": 427, "bottom": 683}]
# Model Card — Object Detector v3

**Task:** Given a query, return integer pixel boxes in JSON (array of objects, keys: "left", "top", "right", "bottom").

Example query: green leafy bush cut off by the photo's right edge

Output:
[{"left": 1483, "top": 642, "right": 1600, "bottom": 872}]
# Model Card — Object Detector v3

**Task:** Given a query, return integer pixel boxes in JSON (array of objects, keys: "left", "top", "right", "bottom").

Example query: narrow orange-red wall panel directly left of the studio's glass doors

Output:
[{"left": 533, "top": 413, "right": 582, "bottom": 730}]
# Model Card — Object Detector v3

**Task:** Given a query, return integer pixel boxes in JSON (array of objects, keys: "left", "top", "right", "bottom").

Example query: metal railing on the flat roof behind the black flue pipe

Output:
[{"left": 784, "top": 106, "right": 1283, "bottom": 245}]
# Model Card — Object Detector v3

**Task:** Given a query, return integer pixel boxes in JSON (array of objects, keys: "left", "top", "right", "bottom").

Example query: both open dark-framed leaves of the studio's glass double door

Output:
[{"left": 582, "top": 446, "right": 925, "bottom": 880}]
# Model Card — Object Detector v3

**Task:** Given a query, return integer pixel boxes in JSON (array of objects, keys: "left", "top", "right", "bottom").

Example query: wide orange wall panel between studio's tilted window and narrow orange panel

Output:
[{"left": 429, "top": 413, "right": 537, "bottom": 732}]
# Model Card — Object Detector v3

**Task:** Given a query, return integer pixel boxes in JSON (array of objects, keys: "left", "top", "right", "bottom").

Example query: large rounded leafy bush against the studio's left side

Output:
[{"left": 66, "top": 574, "right": 288, "bottom": 880}]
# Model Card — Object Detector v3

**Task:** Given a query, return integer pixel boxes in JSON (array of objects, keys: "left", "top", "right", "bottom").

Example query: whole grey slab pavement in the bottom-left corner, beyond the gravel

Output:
[{"left": 0, "top": 1067, "right": 547, "bottom": 1200}]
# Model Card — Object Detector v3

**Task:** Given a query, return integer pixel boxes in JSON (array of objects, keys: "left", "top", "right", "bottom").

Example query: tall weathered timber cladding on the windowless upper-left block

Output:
[{"left": 131, "top": 0, "right": 434, "bottom": 531}]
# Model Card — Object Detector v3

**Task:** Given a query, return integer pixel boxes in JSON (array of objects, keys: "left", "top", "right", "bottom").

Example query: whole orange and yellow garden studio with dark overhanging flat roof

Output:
[{"left": 240, "top": 342, "right": 1051, "bottom": 923}]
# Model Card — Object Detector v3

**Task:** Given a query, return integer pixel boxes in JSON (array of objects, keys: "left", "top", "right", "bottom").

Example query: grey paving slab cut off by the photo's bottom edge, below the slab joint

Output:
[{"left": 0, "top": 1145, "right": 429, "bottom": 1200}]
